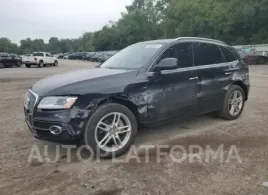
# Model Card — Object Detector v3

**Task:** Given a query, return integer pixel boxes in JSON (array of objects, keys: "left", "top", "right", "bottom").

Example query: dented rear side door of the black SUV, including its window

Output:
[{"left": 194, "top": 42, "right": 229, "bottom": 112}]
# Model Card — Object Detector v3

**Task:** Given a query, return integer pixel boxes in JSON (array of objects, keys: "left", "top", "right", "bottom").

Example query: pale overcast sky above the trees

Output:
[{"left": 0, "top": 0, "right": 133, "bottom": 43}]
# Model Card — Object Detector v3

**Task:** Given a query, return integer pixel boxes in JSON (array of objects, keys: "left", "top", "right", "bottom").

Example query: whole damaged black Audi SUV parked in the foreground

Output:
[{"left": 24, "top": 37, "right": 249, "bottom": 157}]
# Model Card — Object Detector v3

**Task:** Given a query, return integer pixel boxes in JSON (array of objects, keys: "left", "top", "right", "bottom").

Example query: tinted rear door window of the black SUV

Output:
[{"left": 194, "top": 43, "right": 223, "bottom": 66}]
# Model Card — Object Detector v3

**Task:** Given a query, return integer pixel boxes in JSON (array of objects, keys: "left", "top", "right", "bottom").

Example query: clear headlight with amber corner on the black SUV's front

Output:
[{"left": 38, "top": 96, "right": 77, "bottom": 109}]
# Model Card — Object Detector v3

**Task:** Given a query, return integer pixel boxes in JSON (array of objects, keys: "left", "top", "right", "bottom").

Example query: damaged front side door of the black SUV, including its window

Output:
[{"left": 148, "top": 42, "right": 199, "bottom": 119}]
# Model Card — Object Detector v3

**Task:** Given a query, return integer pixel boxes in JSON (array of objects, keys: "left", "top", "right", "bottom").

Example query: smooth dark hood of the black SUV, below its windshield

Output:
[{"left": 32, "top": 68, "right": 138, "bottom": 96}]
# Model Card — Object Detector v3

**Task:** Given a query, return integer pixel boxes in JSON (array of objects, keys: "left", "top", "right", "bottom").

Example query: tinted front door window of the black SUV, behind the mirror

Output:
[{"left": 158, "top": 43, "right": 193, "bottom": 68}]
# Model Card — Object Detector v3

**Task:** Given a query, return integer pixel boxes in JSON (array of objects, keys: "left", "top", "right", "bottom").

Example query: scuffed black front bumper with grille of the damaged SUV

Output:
[{"left": 24, "top": 92, "right": 90, "bottom": 141}]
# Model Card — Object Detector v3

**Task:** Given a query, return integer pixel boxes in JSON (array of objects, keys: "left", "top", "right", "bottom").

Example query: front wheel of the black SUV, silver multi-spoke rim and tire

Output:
[{"left": 84, "top": 103, "right": 137, "bottom": 158}]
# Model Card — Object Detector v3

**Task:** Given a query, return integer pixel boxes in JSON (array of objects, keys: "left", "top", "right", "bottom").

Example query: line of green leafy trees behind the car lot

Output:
[{"left": 0, "top": 0, "right": 268, "bottom": 54}]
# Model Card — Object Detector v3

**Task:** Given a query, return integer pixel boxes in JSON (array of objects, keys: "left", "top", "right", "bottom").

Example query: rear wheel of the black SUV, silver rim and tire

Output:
[{"left": 219, "top": 85, "right": 245, "bottom": 120}]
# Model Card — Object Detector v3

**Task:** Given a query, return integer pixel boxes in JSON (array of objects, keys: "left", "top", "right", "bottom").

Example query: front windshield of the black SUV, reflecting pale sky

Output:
[{"left": 101, "top": 43, "right": 162, "bottom": 69}]
